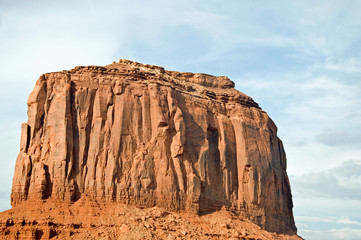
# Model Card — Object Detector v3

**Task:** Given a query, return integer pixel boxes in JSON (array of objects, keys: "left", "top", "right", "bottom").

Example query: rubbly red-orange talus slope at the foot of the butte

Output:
[{"left": 0, "top": 201, "right": 300, "bottom": 240}]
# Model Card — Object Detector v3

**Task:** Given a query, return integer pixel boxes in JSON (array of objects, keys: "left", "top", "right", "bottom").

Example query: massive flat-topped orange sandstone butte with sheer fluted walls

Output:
[{"left": 11, "top": 60, "right": 296, "bottom": 233}]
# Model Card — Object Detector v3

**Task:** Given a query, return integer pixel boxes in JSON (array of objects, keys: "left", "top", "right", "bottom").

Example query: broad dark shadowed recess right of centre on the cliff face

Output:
[{"left": 177, "top": 94, "right": 230, "bottom": 215}]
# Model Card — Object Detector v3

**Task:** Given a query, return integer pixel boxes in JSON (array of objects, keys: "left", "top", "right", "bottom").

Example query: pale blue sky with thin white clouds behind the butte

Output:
[{"left": 0, "top": 0, "right": 361, "bottom": 240}]
